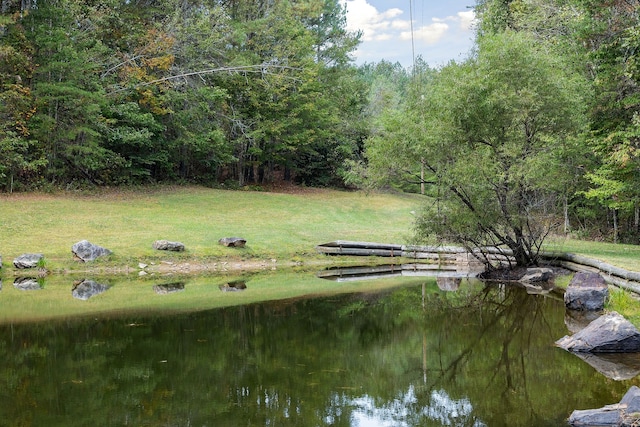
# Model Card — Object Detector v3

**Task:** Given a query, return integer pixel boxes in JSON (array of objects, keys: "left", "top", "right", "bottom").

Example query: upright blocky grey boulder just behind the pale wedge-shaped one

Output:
[{"left": 564, "top": 272, "right": 609, "bottom": 311}]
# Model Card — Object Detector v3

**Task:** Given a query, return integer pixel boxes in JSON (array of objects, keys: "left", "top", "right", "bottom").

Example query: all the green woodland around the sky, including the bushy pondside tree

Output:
[{"left": 0, "top": 0, "right": 640, "bottom": 246}]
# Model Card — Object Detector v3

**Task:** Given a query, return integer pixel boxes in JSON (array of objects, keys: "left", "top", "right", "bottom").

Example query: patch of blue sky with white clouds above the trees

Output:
[{"left": 345, "top": 0, "right": 475, "bottom": 68}]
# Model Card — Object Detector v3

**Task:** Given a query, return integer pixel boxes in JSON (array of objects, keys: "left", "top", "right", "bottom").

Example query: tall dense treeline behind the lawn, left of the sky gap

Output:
[{"left": 0, "top": 0, "right": 365, "bottom": 190}]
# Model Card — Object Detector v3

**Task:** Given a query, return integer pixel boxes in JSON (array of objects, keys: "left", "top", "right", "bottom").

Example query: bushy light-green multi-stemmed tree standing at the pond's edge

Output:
[{"left": 410, "top": 32, "right": 586, "bottom": 266}]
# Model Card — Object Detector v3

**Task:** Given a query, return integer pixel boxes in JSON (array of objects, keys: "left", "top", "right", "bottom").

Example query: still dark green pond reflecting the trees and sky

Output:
[{"left": 0, "top": 273, "right": 636, "bottom": 427}]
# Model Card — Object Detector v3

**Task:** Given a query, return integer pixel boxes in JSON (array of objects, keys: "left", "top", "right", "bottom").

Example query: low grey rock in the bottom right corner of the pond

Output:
[{"left": 569, "top": 386, "right": 640, "bottom": 427}]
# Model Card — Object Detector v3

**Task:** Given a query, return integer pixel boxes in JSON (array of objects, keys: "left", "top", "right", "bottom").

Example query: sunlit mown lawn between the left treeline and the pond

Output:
[{"left": 0, "top": 187, "right": 420, "bottom": 271}]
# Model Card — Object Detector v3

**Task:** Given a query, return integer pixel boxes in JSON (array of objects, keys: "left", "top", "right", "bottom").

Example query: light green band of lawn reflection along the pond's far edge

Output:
[{"left": 0, "top": 269, "right": 436, "bottom": 323}]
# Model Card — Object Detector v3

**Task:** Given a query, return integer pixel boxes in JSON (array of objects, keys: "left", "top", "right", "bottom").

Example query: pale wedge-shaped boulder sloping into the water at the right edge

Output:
[{"left": 556, "top": 312, "right": 640, "bottom": 353}]
